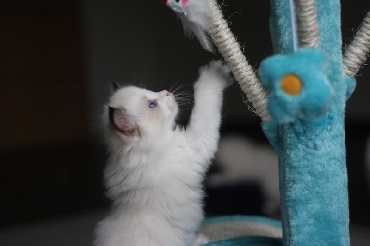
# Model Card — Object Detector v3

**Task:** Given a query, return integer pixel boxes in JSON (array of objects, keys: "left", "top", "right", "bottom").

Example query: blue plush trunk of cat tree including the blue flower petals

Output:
[{"left": 259, "top": 0, "right": 354, "bottom": 246}]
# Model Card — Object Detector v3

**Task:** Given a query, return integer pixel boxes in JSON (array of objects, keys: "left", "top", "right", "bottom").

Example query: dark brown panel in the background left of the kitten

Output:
[{"left": 0, "top": 0, "right": 88, "bottom": 152}]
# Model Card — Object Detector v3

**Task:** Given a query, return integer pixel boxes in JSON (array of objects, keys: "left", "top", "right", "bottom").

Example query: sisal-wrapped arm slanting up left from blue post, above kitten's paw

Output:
[{"left": 209, "top": 0, "right": 271, "bottom": 122}]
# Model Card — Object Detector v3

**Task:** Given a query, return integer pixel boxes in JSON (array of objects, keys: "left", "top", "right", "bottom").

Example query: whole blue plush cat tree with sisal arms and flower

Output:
[{"left": 165, "top": 0, "right": 370, "bottom": 246}]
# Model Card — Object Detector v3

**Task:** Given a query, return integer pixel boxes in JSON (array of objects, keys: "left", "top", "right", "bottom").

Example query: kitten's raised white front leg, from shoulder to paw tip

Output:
[{"left": 187, "top": 61, "right": 232, "bottom": 158}]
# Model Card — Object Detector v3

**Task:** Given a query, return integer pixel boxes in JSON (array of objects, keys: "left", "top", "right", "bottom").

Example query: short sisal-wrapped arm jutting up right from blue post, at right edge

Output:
[{"left": 343, "top": 11, "right": 370, "bottom": 77}]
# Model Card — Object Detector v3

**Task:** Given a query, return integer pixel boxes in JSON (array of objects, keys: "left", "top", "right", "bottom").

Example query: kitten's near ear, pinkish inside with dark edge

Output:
[{"left": 108, "top": 107, "right": 137, "bottom": 136}]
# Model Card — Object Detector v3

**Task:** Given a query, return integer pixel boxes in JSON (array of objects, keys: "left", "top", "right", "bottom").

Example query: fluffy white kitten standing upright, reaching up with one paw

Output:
[{"left": 95, "top": 61, "right": 231, "bottom": 246}]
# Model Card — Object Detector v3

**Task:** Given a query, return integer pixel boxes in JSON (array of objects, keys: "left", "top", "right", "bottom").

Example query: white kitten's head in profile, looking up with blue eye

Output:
[{"left": 106, "top": 86, "right": 178, "bottom": 142}]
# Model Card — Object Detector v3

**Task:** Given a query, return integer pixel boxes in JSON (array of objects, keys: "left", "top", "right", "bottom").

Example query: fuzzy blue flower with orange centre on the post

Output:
[{"left": 259, "top": 48, "right": 334, "bottom": 123}]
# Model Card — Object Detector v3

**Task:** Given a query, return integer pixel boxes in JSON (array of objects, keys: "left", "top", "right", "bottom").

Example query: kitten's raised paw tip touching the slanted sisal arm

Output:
[{"left": 199, "top": 60, "right": 233, "bottom": 88}]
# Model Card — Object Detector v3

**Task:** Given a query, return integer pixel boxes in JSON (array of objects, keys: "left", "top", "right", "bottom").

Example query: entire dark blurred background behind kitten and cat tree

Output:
[{"left": 0, "top": 0, "right": 370, "bottom": 245}]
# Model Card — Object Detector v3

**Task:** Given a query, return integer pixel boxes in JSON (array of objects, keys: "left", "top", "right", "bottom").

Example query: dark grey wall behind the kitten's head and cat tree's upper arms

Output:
[{"left": 82, "top": 0, "right": 370, "bottom": 138}]
